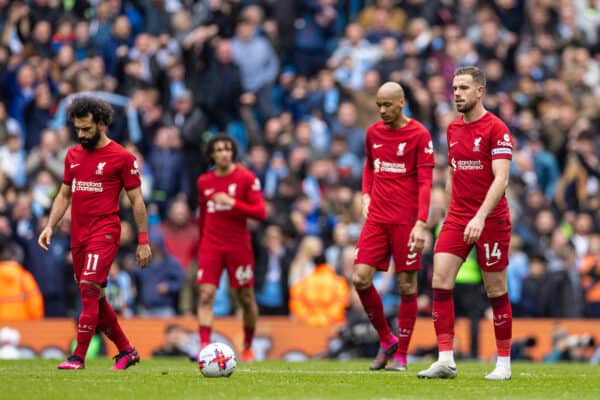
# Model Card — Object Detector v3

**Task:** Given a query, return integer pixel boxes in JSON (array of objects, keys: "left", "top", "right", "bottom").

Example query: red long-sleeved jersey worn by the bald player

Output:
[{"left": 363, "top": 119, "right": 434, "bottom": 224}]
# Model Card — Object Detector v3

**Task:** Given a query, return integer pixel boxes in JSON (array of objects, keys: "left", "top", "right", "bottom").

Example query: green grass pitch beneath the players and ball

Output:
[{"left": 0, "top": 359, "right": 600, "bottom": 400}]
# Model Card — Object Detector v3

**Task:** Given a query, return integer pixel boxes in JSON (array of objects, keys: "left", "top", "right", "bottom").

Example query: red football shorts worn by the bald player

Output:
[{"left": 354, "top": 218, "right": 421, "bottom": 272}]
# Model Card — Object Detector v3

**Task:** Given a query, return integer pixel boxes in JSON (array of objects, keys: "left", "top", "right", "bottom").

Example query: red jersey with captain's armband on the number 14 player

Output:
[{"left": 447, "top": 112, "right": 513, "bottom": 226}]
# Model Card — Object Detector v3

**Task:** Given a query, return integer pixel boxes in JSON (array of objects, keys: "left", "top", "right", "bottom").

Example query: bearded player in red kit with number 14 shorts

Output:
[{"left": 418, "top": 66, "right": 513, "bottom": 380}]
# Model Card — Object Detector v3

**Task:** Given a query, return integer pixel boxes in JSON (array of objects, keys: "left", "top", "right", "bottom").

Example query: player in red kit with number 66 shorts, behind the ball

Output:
[{"left": 197, "top": 135, "right": 266, "bottom": 362}]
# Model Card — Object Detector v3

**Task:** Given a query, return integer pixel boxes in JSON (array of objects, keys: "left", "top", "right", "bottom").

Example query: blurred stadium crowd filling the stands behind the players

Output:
[{"left": 0, "top": 0, "right": 600, "bottom": 332}]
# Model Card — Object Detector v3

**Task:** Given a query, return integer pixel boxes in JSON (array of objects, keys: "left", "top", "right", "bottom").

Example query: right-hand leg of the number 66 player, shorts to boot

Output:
[{"left": 226, "top": 247, "right": 258, "bottom": 362}]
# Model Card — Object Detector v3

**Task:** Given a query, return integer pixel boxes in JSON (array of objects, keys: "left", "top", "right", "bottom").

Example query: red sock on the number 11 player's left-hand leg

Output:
[{"left": 73, "top": 283, "right": 100, "bottom": 360}]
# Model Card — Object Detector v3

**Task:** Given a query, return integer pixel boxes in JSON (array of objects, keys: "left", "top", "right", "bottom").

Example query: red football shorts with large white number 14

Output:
[{"left": 434, "top": 221, "right": 510, "bottom": 272}]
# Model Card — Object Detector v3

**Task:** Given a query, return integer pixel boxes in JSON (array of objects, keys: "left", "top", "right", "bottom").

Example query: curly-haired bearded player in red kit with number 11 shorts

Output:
[{"left": 38, "top": 97, "right": 151, "bottom": 370}]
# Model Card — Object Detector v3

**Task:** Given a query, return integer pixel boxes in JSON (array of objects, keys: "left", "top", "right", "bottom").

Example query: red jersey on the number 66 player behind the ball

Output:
[{"left": 197, "top": 165, "right": 266, "bottom": 249}]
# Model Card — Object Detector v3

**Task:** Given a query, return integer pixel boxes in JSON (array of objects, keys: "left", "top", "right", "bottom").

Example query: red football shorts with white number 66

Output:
[{"left": 196, "top": 246, "right": 254, "bottom": 289}]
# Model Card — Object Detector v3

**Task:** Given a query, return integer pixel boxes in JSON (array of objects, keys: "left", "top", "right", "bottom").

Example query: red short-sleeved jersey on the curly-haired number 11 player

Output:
[{"left": 63, "top": 141, "right": 141, "bottom": 247}]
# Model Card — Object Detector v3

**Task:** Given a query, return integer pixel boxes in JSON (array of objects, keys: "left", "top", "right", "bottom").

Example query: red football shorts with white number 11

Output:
[{"left": 71, "top": 239, "right": 119, "bottom": 287}]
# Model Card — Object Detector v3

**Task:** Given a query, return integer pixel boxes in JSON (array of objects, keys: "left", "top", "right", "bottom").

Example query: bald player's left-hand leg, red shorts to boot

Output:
[{"left": 352, "top": 220, "right": 398, "bottom": 370}]
